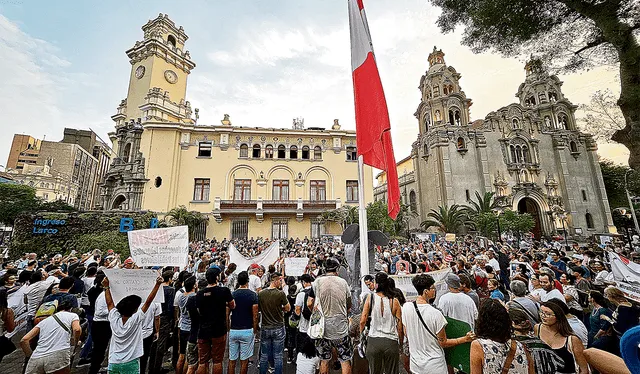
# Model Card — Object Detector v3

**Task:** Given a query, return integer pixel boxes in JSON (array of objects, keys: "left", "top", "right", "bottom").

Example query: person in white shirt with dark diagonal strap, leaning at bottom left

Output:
[{"left": 20, "top": 300, "right": 82, "bottom": 373}]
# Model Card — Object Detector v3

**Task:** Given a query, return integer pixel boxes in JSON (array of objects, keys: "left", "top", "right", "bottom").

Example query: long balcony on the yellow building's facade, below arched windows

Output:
[{"left": 213, "top": 197, "right": 342, "bottom": 222}]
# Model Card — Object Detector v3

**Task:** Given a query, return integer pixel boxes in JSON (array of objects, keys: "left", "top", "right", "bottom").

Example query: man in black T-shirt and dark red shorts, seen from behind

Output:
[{"left": 195, "top": 267, "right": 236, "bottom": 374}]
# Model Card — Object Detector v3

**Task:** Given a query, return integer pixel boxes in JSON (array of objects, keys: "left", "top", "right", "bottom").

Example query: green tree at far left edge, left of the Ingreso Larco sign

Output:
[{"left": 0, "top": 183, "right": 39, "bottom": 225}]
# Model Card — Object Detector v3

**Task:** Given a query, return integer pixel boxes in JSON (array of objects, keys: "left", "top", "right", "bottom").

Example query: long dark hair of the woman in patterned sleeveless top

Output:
[{"left": 476, "top": 299, "right": 512, "bottom": 343}]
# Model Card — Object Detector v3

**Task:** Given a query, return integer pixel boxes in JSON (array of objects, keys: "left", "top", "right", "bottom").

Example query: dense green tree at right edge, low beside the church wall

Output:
[{"left": 600, "top": 160, "right": 640, "bottom": 209}]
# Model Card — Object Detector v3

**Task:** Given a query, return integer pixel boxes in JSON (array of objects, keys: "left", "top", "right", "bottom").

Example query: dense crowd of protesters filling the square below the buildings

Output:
[{"left": 0, "top": 236, "right": 640, "bottom": 374}]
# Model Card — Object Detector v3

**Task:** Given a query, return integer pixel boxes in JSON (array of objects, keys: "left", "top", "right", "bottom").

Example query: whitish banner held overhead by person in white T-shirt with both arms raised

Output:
[{"left": 104, "top": 269, "right": 164, "bottom": 304}]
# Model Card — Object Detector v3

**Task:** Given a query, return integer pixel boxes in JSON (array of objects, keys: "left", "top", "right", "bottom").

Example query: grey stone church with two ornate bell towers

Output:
[{"left": 374, "top": 47, "right": 615, "bottom": 238}]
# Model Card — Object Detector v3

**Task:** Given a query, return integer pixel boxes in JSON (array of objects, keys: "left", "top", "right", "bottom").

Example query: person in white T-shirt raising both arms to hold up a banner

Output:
[{"left": 102, "top": 277, "right": 164, "bottom": 373}]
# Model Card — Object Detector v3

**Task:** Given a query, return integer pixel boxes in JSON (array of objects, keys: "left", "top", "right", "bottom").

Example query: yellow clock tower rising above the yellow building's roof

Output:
[{"left": 111, "top": 13, "right": 196, "bottom": 127}]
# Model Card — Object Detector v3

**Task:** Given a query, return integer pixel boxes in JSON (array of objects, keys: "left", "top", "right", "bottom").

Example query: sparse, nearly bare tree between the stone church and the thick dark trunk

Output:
[{"left": 580, "top": 90, "right": 625, "bottom": 142}]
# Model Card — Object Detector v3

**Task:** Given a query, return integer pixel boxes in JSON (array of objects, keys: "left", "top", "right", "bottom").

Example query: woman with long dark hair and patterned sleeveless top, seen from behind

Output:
[{"left": 471, "top": 299, "right": 535, "bottom": 374}]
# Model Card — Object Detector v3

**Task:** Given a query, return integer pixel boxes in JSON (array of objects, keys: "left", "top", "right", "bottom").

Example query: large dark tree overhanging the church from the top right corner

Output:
[{"left": 431, "top": 0, "right": 640, "bottom": 170}]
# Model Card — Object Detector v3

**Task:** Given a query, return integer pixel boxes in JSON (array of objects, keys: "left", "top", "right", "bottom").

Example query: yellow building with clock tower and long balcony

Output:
[{"left": 102, "top": 14, "right": 373, "bottom": 239}]
